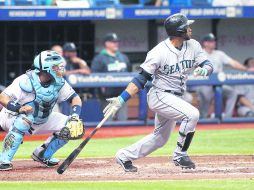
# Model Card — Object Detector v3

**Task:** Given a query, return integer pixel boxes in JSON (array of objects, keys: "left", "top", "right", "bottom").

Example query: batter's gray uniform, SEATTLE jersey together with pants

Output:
[{"left": 116, "top": 39, "right": 210, "bottom": 162}]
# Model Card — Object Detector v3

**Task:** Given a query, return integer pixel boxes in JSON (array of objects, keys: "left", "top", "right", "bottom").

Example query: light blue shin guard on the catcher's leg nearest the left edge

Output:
[{"left": 1, "top": 114, "right": 33, "bottom": 163}]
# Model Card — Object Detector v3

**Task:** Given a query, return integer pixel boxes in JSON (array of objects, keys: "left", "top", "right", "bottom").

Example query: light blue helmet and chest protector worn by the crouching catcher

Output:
[{"left": 20, "top": 50, "right": 65, "bottom": 124}]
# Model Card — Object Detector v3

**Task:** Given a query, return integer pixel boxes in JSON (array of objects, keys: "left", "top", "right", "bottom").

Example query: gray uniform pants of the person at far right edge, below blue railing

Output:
[{"left": 235, "top": 85, "right": 254, "bottom": 117}]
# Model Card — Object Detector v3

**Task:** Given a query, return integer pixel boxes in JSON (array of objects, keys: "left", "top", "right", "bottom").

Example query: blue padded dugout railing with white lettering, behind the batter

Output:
[{"left": 66, "top": 72, "right": 254, "bottom": 88}]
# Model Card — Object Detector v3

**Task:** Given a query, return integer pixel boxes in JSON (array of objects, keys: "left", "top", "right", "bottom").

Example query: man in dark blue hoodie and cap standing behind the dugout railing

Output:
[{"left": 91, "top": 33, "right": 130, "bottom": 121}]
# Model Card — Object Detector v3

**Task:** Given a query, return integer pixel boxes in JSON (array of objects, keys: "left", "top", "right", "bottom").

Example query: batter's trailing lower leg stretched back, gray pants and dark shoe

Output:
[{"left": 116, "top": 114, "right": 176, "bottom": 171}]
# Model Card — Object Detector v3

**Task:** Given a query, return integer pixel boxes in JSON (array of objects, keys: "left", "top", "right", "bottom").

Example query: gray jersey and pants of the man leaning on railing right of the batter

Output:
[{"left": 197, "top": 50, "right": 237, "bottom": 118}]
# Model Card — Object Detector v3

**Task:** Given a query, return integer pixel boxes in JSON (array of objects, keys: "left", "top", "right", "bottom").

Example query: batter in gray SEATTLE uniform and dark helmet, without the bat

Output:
[{"left": 104, "top": 14, "right": 213, "bottom": 172}]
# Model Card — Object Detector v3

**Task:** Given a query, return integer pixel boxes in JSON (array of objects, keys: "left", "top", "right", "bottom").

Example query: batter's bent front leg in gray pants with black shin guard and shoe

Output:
[{"left": 149, "top": 91, "right": 199, "bottom": 168}]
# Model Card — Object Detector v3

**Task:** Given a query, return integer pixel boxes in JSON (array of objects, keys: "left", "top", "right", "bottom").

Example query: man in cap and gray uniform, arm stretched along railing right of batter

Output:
[{"left": 197, "top": 33, "right": 246, "bottom": 118}]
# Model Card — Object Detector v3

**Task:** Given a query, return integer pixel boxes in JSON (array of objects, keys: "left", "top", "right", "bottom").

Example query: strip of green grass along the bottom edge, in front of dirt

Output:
[{"left": 0, "top": 180, "right": 254, "bottom": 190}]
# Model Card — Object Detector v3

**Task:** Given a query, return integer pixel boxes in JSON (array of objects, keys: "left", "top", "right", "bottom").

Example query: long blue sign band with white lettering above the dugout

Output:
[{"left": 0, "top": 6, "right": 254, "bottom": 21}]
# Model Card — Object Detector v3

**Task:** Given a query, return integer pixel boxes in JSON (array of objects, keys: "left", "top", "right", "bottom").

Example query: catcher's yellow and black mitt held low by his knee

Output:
[{"left": 55, "top": 116, "right": 85, "bottom": 140}]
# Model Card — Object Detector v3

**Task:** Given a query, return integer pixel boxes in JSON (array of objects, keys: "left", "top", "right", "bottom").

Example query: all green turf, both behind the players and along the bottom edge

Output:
[{"left": 0, "top": 129, "right": 254, "bottom": 190}]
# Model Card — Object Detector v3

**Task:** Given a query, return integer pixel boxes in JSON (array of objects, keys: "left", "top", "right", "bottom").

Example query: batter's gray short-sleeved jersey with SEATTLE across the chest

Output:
[{"left": 140, "top": 38, "right": 207, "bottom": 93}]
